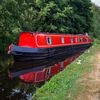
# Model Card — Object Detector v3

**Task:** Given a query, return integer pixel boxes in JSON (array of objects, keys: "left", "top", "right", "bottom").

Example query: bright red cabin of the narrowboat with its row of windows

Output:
[{"left": 19, "top": 32, "right": 92, "bottom": 48}]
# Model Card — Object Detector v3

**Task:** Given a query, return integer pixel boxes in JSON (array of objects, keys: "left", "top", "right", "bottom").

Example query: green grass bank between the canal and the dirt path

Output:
[{"left": 33, "top": 40, "right": 100, "bottom": 100}]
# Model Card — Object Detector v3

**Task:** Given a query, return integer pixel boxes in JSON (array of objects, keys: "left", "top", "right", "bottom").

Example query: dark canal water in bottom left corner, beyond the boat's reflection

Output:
[{"left": 0, "top": 56, "right": 36, "bottom": 100}]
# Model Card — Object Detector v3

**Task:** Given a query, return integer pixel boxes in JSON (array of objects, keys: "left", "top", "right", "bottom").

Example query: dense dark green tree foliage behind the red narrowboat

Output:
[{"left": 0, "top": 0, "right": 92, "bottom": 53}]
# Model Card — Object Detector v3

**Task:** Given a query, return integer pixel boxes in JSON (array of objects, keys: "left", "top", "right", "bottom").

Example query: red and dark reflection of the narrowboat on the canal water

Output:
[{"left": 9, "top": 54, "right": 80, "bottom": 83}]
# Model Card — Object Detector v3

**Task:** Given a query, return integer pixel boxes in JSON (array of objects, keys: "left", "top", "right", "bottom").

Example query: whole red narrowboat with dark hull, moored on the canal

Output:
[{"left": 8, "top": 32, "right": 92, "bottom": 63}]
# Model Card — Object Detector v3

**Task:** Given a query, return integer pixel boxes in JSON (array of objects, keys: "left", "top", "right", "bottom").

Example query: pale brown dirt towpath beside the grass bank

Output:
[{"left": 75, "top": 52, "right": 100, "bottom": 100}]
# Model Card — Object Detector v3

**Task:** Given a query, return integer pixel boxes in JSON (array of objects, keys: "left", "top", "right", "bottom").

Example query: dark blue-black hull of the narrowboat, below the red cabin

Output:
[{"left": 11, "top": 44, "right": 91, "bottom": 63}]
